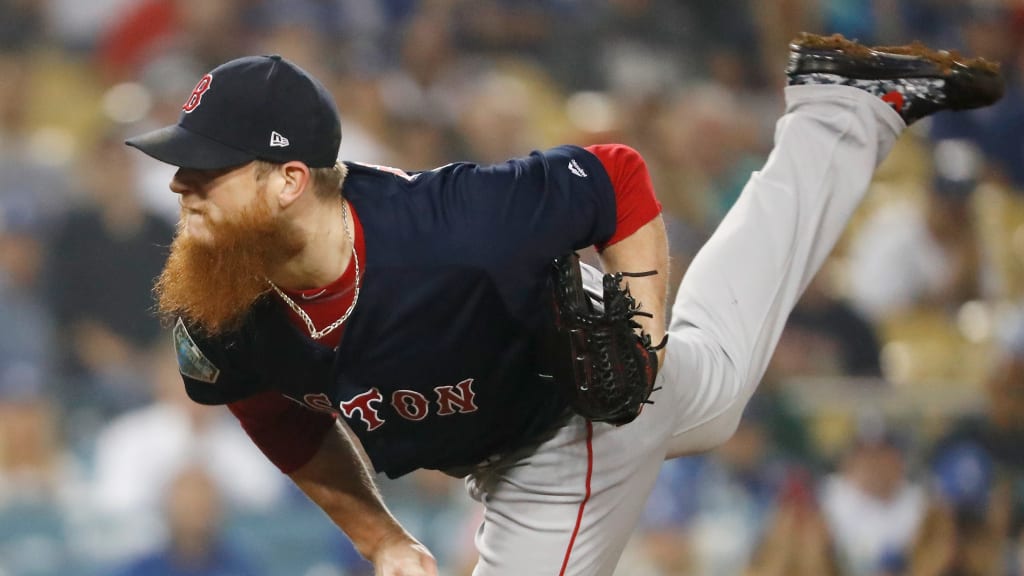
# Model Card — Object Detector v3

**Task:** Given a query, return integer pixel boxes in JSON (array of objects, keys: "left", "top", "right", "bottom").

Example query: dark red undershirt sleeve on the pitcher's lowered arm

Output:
[{"left": 227, "top": 392, "right": 335, "bottom": 474}]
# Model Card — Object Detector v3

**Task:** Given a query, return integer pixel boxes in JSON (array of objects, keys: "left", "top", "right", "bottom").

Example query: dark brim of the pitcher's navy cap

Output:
[{"left": 125, "top": 124, "right": 255, "bottom": 170}]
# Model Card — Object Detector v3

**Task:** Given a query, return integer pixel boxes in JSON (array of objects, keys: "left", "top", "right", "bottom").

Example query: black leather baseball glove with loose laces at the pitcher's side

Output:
[{"left": 542, "top": 252, "right": 666, "bottom": 425}]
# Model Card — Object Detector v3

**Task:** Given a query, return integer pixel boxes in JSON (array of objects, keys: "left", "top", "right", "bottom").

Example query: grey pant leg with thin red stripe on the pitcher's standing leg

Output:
[{"left": 467, "top": 405, "right": 672, "bottom": 576}]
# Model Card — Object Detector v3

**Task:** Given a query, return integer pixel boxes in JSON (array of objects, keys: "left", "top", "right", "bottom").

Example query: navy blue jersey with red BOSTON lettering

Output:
[{"left": 175, "top": 147, "right": 615, "bottom": 478}]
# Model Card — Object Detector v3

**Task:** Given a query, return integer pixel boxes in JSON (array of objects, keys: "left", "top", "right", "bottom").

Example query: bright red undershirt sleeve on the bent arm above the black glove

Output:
[{"left": 586, "top": 143, "right": 662, "bottom": 250}]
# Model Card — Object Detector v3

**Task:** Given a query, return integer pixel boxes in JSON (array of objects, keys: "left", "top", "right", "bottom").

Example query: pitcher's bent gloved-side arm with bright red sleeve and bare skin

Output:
[{"left": 586, "top": 145, "right": 669, "bottom": 362}]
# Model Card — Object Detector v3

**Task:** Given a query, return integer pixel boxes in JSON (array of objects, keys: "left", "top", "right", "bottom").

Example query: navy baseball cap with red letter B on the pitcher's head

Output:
[{"left": 125, "top": 55, "right": 341, "bottom": 170}]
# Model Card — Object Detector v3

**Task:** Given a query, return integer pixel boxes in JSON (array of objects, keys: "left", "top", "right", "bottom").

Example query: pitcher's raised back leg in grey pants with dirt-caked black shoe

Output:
[{"left": 652, "top": 35, "right": 1002, "bottom": 457}]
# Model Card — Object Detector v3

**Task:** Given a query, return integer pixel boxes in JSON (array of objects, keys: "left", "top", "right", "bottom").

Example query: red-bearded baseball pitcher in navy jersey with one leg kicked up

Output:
[{"left": 128, "top": 35, "right": 1002, "bottom": 576}]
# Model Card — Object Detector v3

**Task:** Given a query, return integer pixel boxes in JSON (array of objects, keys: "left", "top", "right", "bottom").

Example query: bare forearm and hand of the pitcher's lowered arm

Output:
[{"left": 288, "top": 422, "right": 437, "bottom": 576}]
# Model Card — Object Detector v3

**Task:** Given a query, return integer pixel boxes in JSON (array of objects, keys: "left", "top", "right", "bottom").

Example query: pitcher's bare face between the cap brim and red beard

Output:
[{"left": 171, "top": 163, "right": 265, "bottom": 244}]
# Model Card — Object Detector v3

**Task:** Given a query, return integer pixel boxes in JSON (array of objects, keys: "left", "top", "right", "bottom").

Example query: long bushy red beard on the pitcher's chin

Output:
[{"left": 154, "top": 202, "right": 304, "bottom": 335}]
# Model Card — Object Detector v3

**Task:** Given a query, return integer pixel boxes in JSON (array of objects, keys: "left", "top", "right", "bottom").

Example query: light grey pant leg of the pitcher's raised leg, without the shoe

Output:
[{"left": 659, "top": 86, "right": 905, "bottom": 457}]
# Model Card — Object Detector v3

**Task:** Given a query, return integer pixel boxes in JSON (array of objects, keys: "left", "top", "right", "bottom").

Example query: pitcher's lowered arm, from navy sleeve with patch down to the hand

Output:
[{"left": 174, "top": 321, "right": 437, "bottom": 576}]
